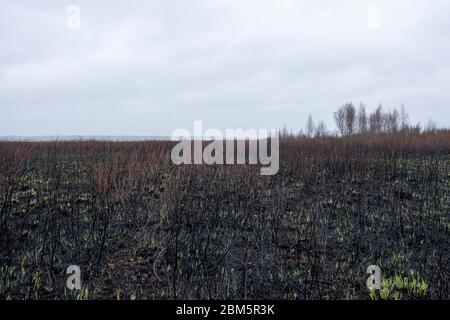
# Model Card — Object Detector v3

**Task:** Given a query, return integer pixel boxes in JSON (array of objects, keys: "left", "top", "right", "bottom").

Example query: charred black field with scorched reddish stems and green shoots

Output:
[{"left": 0, "top": 132, "right": 450, "bottom": 299}]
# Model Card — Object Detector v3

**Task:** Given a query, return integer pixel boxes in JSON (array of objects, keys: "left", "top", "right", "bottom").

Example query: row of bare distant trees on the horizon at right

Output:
[{"left": 298, "top": 103, "right": 437, "bottom": 137}]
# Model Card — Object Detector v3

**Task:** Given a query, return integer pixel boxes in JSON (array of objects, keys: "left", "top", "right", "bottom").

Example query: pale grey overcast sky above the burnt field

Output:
[{"left": 0, "top": 0, "right": 450, "bottom": 135}]
